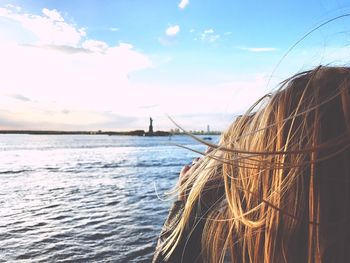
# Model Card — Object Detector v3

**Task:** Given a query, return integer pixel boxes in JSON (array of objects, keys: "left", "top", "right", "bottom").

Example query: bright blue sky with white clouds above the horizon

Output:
[{"left": 0, "top": 0, "right": 350, "bottom": 131}]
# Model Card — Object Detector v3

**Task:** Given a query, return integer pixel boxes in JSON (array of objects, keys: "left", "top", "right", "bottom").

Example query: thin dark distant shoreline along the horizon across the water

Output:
[{"left": 0, "top": 130, "right": 221, "bottom": 137}]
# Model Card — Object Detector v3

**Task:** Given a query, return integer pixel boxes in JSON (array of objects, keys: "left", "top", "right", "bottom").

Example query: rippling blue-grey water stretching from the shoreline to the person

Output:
[{"left": 0, "top": 135, "right": 217, "bottom": 263}]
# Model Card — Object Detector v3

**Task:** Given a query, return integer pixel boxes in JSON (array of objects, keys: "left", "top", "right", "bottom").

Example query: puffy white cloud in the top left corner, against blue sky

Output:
[{"left": 0, "top": 8, "right": 86, "bottom": 46}]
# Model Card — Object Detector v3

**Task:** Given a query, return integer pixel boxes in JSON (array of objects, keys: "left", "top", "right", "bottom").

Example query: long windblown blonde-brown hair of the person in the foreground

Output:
[{"left": 163, "top": 66, "right": 350, "bottom": 263}]
